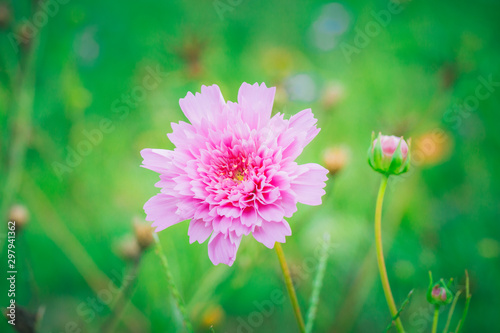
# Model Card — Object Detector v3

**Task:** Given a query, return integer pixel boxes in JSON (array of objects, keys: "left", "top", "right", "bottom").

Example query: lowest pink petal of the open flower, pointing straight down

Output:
[{"left": 208, "top": 232, "right": 241, "bottom": 266}]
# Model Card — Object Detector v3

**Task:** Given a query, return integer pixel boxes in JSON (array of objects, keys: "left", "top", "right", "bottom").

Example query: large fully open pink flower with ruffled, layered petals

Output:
[{"left": 141, "top": 83, "right": 328, "bottom": 266}]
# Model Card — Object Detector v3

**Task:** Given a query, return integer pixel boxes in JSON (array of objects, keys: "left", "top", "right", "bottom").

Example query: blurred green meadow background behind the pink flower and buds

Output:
[{"left": 0, "top": 0, "right": 500, "bottom": 333}]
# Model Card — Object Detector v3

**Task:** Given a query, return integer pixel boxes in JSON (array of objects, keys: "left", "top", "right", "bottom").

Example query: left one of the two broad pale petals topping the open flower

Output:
[{"left": 179, "top": 84, "right": 226, "bottom": 126}]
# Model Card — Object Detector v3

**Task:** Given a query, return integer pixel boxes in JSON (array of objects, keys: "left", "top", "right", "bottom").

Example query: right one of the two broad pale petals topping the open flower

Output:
[{"left": 238, "top": 82, "right": 276, "bottom": 129}]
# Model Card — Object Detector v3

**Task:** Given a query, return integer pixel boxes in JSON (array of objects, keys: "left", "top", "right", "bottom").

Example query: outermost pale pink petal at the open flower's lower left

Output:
[{"left": 144, "top": 193, "right": 184, "bottom": 232}]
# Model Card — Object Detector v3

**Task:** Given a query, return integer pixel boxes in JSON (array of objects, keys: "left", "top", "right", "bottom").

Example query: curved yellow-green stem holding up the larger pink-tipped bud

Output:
[{"left": 375, "top": 175, "right": 405, "bottom": 332}]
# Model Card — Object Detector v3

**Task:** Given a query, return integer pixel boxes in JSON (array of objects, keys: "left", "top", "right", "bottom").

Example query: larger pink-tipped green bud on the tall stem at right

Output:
[{"left": 368, "top": 133, "right": 410, "bottom": 175}]
